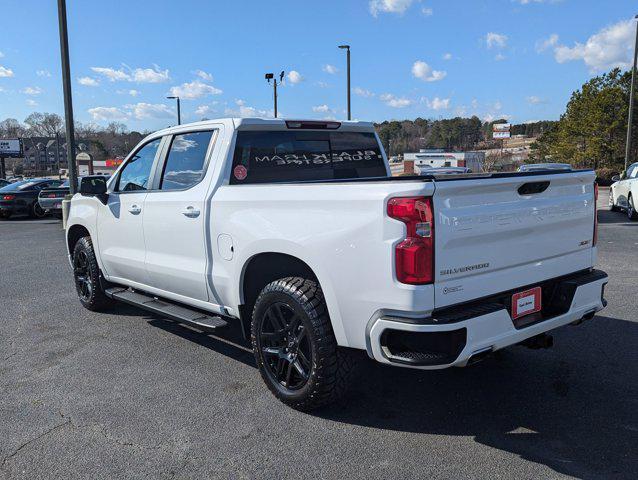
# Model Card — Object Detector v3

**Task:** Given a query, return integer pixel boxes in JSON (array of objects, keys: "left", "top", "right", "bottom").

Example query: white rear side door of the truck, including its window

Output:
[{"left": 144, "top": 127, "right": 217, "bottom": 301}]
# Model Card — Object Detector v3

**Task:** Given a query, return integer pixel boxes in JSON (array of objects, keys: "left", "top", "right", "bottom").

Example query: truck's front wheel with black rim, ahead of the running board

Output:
[{"left": 73, "top": 237, "right": 115, "bottom": 312}]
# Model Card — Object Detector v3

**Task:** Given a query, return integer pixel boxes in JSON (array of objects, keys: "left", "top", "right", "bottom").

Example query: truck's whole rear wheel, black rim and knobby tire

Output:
[{"left": 251, "top": 277, "right": 354, "bottom": 411}]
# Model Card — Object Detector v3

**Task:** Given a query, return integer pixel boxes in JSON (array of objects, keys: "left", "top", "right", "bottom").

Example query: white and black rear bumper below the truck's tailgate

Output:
[{"left": 366, "top": 270, "right": 608, "bottom": 369}]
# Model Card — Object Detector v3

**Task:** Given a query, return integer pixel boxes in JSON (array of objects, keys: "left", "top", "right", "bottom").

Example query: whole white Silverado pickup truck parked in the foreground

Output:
[{"left": 66, "top": 119, "right": 607, "bottom": 410}]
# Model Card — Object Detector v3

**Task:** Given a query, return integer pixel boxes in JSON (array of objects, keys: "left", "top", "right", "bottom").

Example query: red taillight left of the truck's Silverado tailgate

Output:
[{"left": 388, "top": 197, "right": 434, "bottom": 285}]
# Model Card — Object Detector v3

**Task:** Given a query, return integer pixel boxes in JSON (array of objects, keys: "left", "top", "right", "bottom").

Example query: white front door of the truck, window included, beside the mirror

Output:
[{"left": 97, "top": 138, "right": 161, "bottom": 285}]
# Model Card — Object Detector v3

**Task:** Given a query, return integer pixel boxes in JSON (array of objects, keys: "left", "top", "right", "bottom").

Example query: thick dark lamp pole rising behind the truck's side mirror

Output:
[{"left": 58, "top": 0, "right": 78, "bottom": 195}]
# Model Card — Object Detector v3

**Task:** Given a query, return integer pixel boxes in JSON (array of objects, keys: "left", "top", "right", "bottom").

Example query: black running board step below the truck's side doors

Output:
[{"left": 104, "top": 287, "right": 228, "bottom": 331}]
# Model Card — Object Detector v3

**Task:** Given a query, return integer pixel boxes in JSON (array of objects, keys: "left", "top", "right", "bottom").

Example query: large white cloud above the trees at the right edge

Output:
[{"left": 554, "top": 20, "right": 636, "bottom": 73}]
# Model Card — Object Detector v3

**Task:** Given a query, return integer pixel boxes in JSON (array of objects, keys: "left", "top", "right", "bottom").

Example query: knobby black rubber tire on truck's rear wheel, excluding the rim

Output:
[{"left": 251, "top": 277, "right": 356, "bottom": 411}]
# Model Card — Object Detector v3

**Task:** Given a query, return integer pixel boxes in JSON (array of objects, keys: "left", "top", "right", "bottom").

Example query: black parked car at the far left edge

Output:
[{"left": 0, "top": 178, "right": 62, "bottom": 218}]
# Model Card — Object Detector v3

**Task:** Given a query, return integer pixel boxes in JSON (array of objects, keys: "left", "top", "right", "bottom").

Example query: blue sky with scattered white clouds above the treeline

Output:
[{"left": 0, "top": 0, "right": 638, "bottom": 130}]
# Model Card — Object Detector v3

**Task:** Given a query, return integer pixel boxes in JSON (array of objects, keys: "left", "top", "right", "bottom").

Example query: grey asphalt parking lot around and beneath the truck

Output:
[{"left": 0, "top": 195, "right": 638, "bottom": 479}]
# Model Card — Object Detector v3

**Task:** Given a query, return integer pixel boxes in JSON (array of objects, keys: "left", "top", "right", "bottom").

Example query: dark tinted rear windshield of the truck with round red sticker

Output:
[{"left": 230, "top": 131, "right": 387, "bottom": 185}]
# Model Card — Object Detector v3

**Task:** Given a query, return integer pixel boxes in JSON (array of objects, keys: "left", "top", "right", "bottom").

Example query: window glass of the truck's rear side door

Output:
[{"left": 160, "top": 131, "right": 213, "bottom": 190}]
